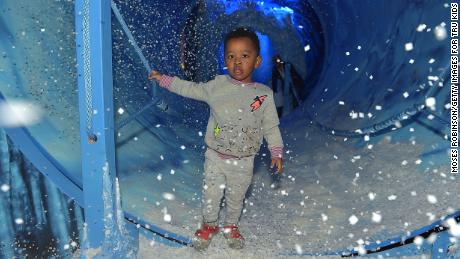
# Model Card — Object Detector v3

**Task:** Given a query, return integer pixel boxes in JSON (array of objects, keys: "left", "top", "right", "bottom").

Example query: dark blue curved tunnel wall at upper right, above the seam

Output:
[{"left": 304, "top": 0, "right": 450, "bottom": 134}]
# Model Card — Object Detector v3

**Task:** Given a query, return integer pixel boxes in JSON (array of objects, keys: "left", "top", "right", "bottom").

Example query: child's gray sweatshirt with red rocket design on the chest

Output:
[{"left": 160, "top": 75, "right": 283, "bottom": 158}]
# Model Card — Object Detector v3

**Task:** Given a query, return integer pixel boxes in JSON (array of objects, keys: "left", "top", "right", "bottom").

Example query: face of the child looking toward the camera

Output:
[{"left": 224, "top": 37, "right": 262, "bottom": 83}]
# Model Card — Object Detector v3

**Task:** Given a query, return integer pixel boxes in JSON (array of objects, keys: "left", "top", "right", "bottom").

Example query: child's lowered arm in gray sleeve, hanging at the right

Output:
[{"left": 262, "top": 92, "right": 283, "bottom": 174}]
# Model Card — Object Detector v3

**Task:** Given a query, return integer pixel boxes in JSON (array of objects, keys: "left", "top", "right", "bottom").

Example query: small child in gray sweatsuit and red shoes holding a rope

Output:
[{"left": 148, "top": 28, "right": 283, "bottom": 251}]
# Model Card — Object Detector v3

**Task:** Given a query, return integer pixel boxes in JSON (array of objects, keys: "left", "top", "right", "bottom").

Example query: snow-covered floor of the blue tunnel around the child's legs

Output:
[{"left": 117, "top": 107, "right": 460, "bottom": 258}]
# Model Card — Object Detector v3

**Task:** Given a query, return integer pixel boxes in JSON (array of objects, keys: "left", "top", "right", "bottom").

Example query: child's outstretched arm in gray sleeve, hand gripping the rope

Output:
[{"left": 148, "top": 70, "right": 209, "bottom": 102}]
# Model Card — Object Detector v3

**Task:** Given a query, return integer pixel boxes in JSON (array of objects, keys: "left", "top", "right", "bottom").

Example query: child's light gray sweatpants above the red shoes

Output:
[{"left": 202, "top": 148, "right": 254, "bottom": 225}]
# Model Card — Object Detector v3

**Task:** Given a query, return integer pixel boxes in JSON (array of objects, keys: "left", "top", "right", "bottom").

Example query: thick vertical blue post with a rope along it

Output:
[{"left": 75, "top": 0, "right": 116, "bottom": 248}]
